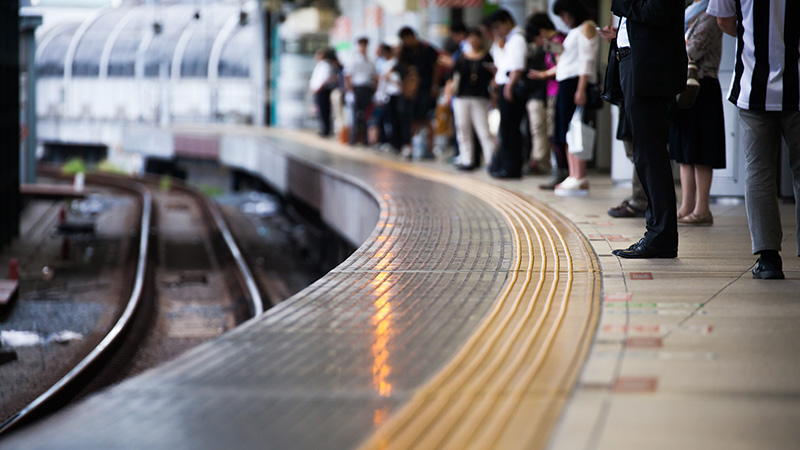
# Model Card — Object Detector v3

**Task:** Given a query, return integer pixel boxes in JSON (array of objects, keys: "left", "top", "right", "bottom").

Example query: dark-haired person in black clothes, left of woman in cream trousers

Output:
[{"left": 398, "top": 27, "right": 440, "bottom": 158}]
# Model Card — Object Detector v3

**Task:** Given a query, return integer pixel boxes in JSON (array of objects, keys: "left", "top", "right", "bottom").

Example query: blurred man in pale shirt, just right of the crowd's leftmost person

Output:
[{"left": 344, "top": 37, "right": 378, "bottom": 145}]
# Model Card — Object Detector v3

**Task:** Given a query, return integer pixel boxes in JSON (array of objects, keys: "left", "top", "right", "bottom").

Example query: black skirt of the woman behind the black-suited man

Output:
[{"left": 669, "top": 78, "right": 725, "bottom": 169}]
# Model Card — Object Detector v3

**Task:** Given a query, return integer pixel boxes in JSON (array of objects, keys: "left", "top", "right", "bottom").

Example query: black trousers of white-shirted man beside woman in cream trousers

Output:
[{"left": 490, "top": 86, "right": 527, "bottom": 178}]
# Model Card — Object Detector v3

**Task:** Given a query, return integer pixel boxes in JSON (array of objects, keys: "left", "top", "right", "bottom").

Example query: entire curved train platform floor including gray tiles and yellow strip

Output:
[{"left": 0, "top": 128, "right": 800, "bottom": 449}]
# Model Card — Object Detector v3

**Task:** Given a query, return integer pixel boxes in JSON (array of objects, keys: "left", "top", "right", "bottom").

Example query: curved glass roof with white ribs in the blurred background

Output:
[{"left": 36, "top": 0, "right": 262, "bottom": 78}]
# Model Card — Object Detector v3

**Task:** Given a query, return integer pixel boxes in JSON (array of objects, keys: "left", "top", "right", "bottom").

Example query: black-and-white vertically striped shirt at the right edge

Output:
[{"left": 706, "top": 0, "right": 800, "bottom": 111}]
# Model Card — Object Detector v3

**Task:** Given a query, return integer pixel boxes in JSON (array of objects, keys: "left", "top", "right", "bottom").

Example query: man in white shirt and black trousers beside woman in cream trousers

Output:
[{"left": 485, "top": 9, "right": 528, "bottom": 178}]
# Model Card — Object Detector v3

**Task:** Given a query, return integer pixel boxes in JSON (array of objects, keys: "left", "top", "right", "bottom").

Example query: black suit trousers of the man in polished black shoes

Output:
[{"left": 619, "top": 56, "right": 678, "bottom": 248}]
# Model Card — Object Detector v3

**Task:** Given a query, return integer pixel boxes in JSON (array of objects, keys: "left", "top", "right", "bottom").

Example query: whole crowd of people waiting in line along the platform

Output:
[{"left": 310, "top": 0, "right": 800, "bottom": 279}]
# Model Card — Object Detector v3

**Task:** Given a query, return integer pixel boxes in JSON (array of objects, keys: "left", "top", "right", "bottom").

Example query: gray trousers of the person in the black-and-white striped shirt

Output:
[{"left": 739, "top": 109, "right": 800, "bottom": 256}]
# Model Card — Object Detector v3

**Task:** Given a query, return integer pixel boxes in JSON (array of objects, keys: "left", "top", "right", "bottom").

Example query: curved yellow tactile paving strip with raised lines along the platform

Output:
[{"left": 278, "top": 131, "right": 601, "bottom": 449}]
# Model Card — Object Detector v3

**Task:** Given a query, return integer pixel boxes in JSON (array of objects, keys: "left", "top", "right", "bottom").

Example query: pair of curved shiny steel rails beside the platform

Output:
[{"left": 0, "top": 168, "right": 264, "bottom": 434}]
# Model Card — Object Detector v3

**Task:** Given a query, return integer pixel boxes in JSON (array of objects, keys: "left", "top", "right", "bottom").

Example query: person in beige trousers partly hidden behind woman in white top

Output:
[{"left": 525, "top": 13, "right": 569, "bottom": 180}]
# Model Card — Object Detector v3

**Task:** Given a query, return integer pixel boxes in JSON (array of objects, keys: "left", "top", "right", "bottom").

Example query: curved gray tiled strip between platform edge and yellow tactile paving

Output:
[{"left": 0, "top": 135, "right": 514, "bottom": 449}]
